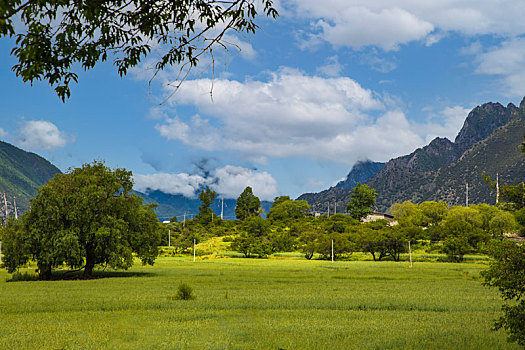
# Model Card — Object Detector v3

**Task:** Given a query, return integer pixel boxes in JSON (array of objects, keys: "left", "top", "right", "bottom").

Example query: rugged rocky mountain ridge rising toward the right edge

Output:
[{"left": 299, "top": 99, "right": 525, "bottom": 212}]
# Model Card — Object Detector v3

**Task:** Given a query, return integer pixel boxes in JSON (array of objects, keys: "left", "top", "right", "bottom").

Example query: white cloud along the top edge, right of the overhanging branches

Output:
[{"left": 285, "top": 0, "right": 525, "bottom": 51}]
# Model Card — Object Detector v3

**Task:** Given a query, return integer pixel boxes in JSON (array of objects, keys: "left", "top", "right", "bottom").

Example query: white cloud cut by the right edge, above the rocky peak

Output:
[{"left": 476, "top": 38, "right": 525, "bottom": 96}]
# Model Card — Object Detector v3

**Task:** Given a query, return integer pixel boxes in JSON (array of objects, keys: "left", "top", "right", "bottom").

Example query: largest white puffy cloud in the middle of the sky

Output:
[{"left": 150, "top": 69, "right": 458, "bottom": 165}]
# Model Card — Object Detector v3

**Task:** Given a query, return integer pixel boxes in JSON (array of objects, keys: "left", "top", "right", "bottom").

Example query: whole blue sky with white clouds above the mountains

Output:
[{"left": 0, "top": 0, "right": 525, "bottom": 199}]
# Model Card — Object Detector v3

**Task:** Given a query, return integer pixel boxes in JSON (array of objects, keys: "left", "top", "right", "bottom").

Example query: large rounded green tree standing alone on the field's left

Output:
[{"left": 4, "top": 161, "right": 161, "bottom": 279}]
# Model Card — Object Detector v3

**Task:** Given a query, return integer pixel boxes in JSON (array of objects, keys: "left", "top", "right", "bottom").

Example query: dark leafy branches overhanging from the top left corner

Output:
[{"left": 0, "top": 0, "right": 277, "bottom": 101}]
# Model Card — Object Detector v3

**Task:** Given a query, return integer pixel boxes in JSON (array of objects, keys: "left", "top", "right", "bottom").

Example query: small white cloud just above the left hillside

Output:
[{"left": 17, "top": 120, "right": 68, "bottom": 151}]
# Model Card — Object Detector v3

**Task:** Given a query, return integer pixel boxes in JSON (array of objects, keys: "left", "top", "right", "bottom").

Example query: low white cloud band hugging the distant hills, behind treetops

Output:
[{"left": 133, "top": 165, "right": 277, "bottom": 200}]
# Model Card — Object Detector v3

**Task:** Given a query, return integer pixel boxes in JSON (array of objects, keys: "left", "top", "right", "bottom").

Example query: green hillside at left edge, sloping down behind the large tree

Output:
[{"left": 0, "top": 141, "right": 60, "bottom": 217}]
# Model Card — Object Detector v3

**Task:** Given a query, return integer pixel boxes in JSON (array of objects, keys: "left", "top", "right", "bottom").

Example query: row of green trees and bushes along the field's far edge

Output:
[{"left": 162, "top": 180, "right": 521, "bottom": 262}]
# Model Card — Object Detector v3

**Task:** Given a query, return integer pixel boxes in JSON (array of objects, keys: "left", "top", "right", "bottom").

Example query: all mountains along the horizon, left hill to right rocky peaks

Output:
[{"left": 0, "top": 99, "right": 525, "bottom": 220}]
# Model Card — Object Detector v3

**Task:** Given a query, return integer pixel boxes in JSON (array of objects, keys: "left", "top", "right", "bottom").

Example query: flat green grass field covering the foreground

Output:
[{"left": 0, "top": 258, "right": 517, "bottom": 349}]
